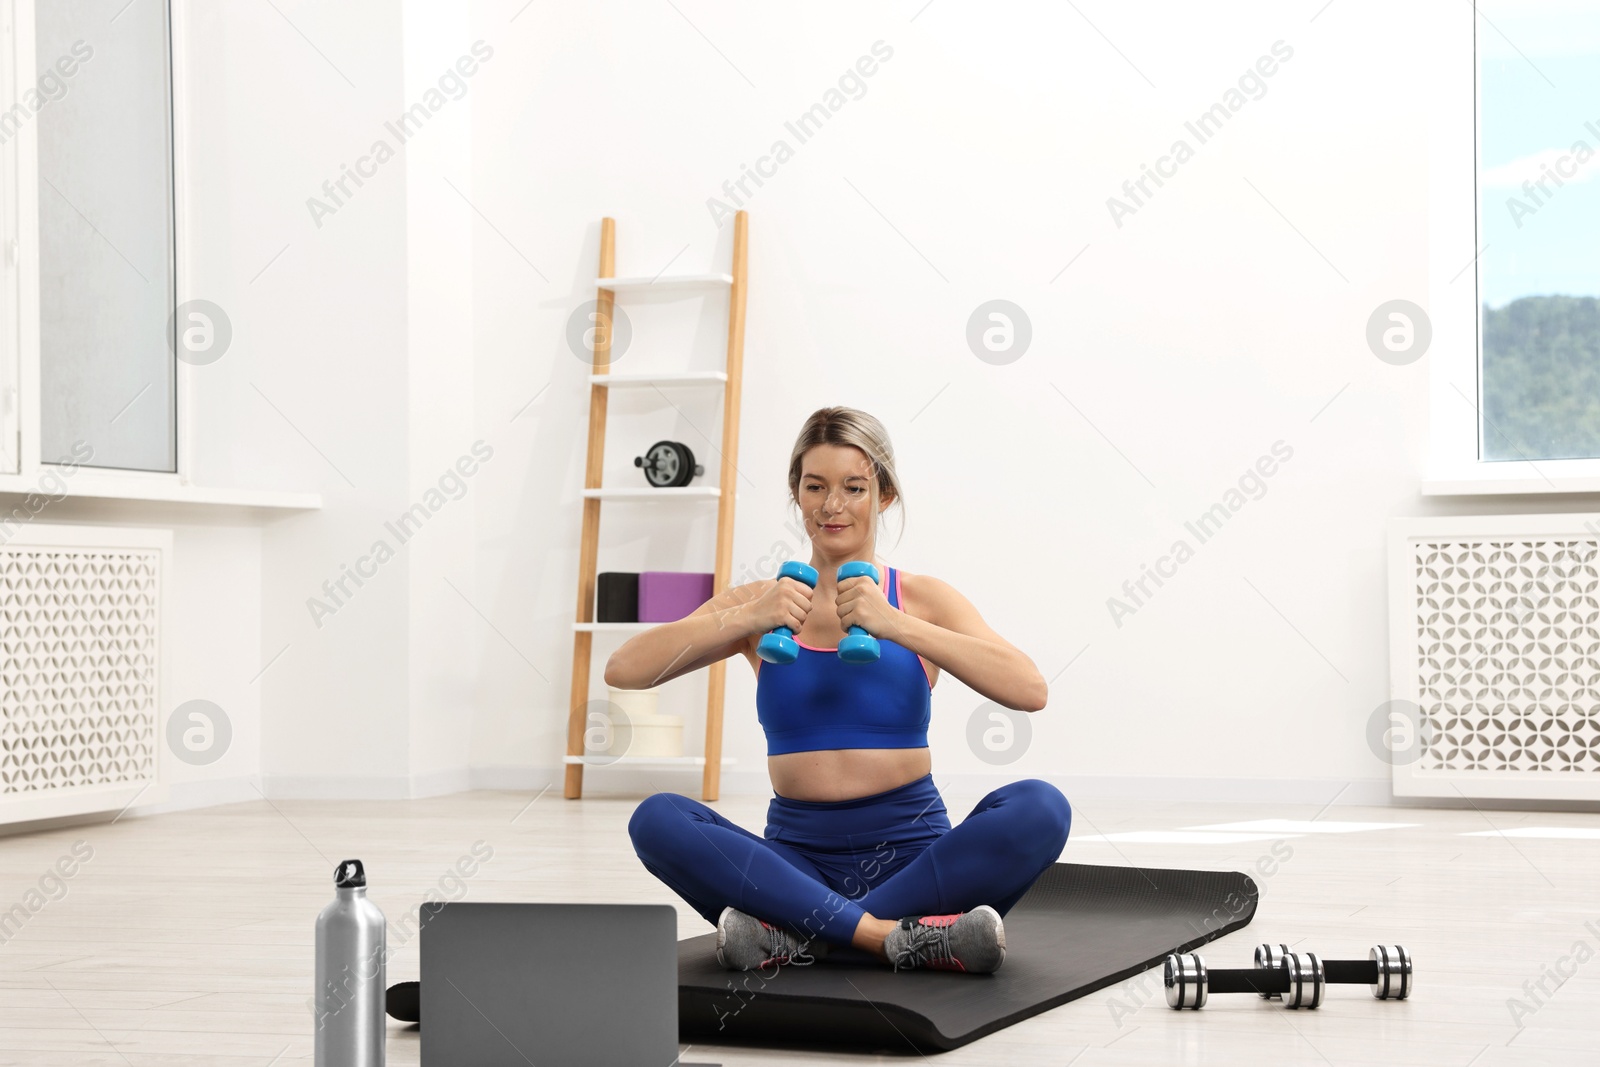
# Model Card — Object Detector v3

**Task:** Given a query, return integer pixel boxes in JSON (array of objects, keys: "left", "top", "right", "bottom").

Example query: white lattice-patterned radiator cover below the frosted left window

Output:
[{"left": 0, "top": 521, "right": 173, "bottom": 822}]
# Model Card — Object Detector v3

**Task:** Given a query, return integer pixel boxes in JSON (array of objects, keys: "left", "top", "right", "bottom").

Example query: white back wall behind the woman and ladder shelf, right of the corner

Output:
[{"left": 457, "top": 0, "right": 1600, "bottom": 803}]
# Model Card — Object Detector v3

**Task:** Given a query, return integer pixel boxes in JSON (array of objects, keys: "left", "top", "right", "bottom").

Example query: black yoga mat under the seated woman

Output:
[{"left": 678, "top": 864, "right": 1259, "bottom": 1054}]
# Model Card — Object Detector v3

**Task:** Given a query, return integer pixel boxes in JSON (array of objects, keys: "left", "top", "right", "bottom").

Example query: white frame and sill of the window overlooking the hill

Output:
[{"left": 1422, "top": 3, "right": 1600, "bottom": 496}]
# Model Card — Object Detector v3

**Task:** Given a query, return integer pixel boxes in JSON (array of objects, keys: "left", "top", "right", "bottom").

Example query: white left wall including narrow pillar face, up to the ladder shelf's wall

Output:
[{"left": 175, "top": 0, "right": 493, "bottom": 797}]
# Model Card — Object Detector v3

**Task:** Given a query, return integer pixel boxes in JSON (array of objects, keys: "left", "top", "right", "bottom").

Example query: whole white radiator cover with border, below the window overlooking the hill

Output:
[{"left": 1389, "top": 514, "right": 1600, "bottom": 800}]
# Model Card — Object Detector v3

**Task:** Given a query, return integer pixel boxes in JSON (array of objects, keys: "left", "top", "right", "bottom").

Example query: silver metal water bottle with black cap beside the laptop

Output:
[{"left": 312, "top": 859, "right": 387, "bottom": 1067}]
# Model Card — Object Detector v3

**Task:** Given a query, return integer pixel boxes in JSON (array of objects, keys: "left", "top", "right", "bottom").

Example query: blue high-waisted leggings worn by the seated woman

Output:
[{"left": 627, "top": 774, "right": 1072, "bottom": 945}]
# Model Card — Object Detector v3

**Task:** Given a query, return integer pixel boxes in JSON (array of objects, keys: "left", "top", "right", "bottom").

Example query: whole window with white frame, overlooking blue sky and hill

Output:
[{"left": 1433, "top": 0, "right": 1600, "bottom": 496}]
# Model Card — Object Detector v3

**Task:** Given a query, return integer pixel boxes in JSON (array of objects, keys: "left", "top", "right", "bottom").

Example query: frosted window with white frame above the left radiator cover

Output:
[{"left": 0, "top": 0, "right": 178, "bottom": 474}]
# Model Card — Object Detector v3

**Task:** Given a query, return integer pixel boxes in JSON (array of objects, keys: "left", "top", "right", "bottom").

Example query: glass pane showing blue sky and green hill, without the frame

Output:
[{"left": 1477, "top": 0, "right": 1600, "bottom": 461}]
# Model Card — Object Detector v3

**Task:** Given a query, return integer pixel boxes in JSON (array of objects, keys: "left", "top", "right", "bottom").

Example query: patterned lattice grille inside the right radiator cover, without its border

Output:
[{"left": 1413, "top": 537, "right": 1600, "bottom": 774}]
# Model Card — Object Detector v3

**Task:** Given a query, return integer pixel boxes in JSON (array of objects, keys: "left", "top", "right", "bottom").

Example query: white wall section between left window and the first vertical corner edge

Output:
[{"left": 189, "top": 2, "right": 410, "bottom": 792}]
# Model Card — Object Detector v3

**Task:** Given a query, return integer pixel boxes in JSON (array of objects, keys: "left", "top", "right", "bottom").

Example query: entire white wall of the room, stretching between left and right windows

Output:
[{"left": 75, "top": 0, "right": 1594, "bottom": 825}]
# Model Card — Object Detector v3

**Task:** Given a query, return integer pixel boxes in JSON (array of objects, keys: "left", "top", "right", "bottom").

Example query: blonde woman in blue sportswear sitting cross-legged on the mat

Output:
[{"left": 605, "top": 408, "right": 1072, "bottom": 973}]
